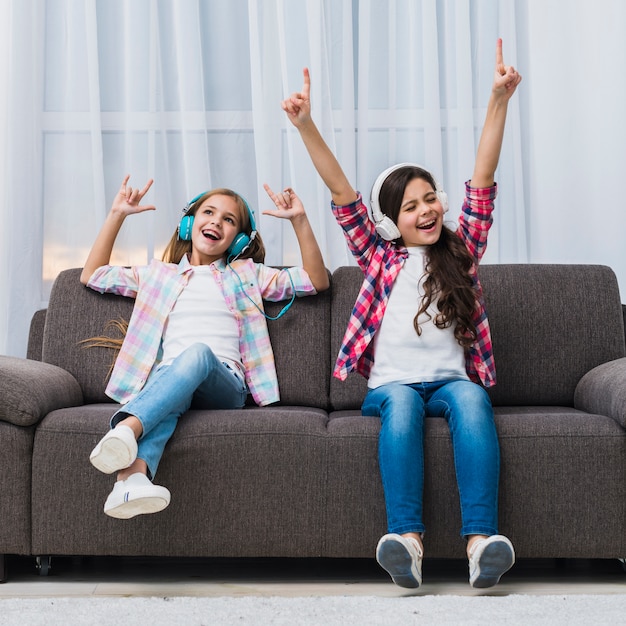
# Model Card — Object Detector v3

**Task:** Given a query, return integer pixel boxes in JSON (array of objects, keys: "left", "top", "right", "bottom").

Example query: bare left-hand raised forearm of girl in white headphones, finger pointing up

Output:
[{"left": 281, "top": 68, "right": 357, "bottom": 205}]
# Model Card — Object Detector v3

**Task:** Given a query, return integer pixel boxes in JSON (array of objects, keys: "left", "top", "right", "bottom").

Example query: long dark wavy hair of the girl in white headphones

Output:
[{"left": 379, "top": 166, "right": 477, "bottom": 348}]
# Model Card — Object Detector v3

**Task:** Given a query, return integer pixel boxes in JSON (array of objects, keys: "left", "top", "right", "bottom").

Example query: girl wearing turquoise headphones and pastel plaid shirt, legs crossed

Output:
[{"left": 80, "top": 176, "right": 329, "bottom": 519}]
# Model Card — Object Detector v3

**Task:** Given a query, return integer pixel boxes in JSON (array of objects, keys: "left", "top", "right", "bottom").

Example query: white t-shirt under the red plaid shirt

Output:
[{"left": 367, "top": 246, "right": 468, "bottom": 389}]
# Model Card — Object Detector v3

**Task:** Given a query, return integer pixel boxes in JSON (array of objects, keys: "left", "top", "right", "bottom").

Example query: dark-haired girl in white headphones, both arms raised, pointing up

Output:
[{"left": 282, "top": 40, "right": 521, "bottom": 588}]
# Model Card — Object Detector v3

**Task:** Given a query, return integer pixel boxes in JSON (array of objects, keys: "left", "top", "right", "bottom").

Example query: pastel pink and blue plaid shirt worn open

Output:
[{"left": 87, "top": 256, "right": 316, "bottom": 406}]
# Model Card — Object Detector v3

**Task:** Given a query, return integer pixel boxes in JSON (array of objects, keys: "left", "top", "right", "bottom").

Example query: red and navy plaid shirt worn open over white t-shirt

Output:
[{"left": 331, "top": 183, "right": 497, "bottom": 387}]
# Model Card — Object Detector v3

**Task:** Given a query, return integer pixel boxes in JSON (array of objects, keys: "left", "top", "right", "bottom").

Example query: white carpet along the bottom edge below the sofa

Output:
[{"left": 0, "top": 593, "right": 626, "bottom": 626}]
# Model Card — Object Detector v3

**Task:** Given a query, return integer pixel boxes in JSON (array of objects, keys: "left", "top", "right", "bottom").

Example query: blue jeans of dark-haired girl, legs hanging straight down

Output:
[{"left": 361, "top": 380, "right": 500, "bottom": 537}]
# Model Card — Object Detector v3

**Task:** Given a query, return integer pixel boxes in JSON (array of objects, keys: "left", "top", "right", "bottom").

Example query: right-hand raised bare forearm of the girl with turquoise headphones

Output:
[{"left": 263, "top": 185, "right": 330, "bottom": 291}]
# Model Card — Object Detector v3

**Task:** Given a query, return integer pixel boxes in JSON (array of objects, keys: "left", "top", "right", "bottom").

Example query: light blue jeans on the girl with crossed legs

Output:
[{"left": 111, "top": 343, "right": 248, "bottom": 478}]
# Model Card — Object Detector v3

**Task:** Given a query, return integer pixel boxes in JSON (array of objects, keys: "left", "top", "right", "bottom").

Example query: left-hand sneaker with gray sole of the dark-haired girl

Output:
[{"left": 376, "top": 533, "right": 424, "bottom": 589}]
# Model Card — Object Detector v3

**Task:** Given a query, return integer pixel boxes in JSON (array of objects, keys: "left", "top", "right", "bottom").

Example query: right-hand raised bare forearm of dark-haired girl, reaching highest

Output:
[{"left": 470, "top": 39, "right": 522, "bottom": 187}]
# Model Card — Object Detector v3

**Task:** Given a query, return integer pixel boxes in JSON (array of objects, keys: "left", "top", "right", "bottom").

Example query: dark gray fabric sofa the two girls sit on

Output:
[{"left": 0, "top": 265, "right": 626, "bottom": 578}]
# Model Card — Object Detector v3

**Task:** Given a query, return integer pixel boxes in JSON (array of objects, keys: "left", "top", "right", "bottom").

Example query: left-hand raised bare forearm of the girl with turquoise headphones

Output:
[{"left": 80, "top": 175, "right": 155, "bottom": 285}]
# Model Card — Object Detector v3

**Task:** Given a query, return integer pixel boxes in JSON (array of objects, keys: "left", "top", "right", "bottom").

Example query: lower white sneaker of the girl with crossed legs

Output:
[{"left": 104, "top": 472, "right": 170, "bottom": 519}]
